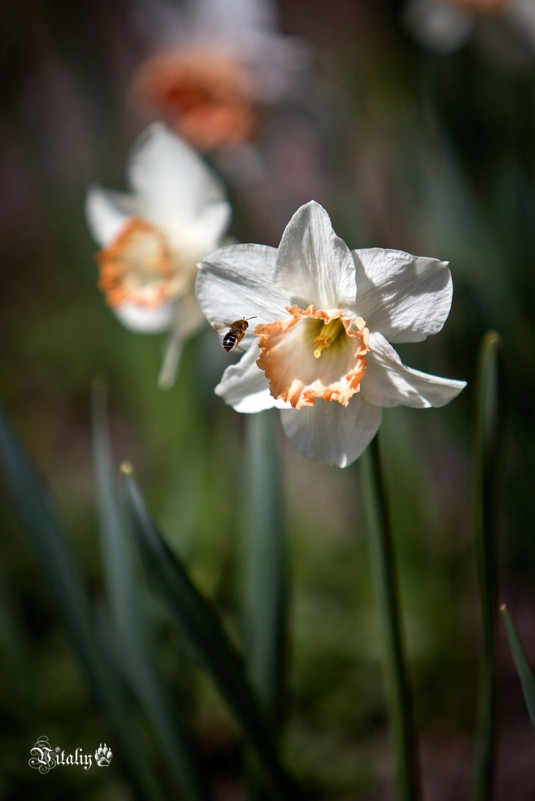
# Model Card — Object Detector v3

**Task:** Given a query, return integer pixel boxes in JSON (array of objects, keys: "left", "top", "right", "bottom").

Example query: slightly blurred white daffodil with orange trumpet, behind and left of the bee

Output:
[{"left": 86, "top": 123, "right": 231, "bottom": 386}]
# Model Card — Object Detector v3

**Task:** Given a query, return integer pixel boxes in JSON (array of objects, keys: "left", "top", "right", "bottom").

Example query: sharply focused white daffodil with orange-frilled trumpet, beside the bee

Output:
[{"left": 196, "top": 202, "right": 466, "bottom": 467}]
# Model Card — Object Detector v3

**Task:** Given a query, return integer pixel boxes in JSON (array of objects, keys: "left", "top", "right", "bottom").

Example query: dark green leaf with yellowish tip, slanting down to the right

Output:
[{"left": 123, "top": 465, "right": 300, "bottom": 801}]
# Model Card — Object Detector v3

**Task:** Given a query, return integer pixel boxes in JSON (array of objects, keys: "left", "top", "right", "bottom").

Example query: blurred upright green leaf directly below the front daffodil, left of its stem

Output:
[{"left": 242, "top": 411, "right": 288, "bottom": 799}]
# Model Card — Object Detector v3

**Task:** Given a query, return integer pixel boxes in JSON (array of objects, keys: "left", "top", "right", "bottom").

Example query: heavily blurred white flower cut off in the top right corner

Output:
[{"left": 405, "top": 0, "right": 535, "bottom": 63}]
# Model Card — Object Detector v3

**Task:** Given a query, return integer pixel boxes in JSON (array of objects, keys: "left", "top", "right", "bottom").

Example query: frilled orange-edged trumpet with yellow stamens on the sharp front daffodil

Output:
[{"left": 255, "top": 306, "right": 370, "bottom": 409}]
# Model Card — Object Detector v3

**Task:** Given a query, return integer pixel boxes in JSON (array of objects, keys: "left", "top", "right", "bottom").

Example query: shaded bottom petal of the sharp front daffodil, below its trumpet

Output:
[{"left": 281, "top": 395, "right": 382, "bottom": 467}]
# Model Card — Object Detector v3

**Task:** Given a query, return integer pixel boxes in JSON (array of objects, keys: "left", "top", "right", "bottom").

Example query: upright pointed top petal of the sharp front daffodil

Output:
[{"left": 275, "top": 201, "right": 357, "bottom": 310}]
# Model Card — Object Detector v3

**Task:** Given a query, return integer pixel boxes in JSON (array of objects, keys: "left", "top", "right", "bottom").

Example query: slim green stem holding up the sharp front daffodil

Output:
[{"left": 365, "top": 437, "right": 420, "bottom": 801}]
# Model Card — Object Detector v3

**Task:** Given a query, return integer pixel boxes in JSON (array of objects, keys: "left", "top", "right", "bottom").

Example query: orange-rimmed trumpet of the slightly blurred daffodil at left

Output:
[{"left": 97, "top": 217, "right": 184, "bottom": 307}]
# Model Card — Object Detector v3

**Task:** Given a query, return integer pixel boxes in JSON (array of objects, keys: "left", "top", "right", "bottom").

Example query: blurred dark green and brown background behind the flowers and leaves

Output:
[{"left": 0, "top": 0, "right": 535, "bottom": 801}]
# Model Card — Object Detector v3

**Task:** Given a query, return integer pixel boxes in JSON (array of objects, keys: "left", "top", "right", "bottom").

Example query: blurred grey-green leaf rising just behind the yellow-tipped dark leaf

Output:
[{"left": 93, "top": 384, "right": 210, "bottom": 801}]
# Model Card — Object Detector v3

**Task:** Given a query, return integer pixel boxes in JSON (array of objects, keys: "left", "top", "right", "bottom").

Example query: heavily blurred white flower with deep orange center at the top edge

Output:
[{"left": 131, "top": 0, "right": 311, "bottom": 153}]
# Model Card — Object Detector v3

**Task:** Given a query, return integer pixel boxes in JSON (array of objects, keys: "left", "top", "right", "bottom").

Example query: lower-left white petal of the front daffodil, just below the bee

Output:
[{"left": 215, "top": 343, "right": 290, "bottom": 413}]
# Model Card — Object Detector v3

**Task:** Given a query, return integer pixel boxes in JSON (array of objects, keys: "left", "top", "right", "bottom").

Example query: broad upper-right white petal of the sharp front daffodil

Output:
[{"left": 353, "top": 248, "right": 453, "bottom": 342}]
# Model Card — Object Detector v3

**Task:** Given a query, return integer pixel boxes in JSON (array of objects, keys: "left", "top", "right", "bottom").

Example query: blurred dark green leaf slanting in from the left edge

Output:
[{"left": 0, "top": 408, "right": 165, "bottom": 801}]
